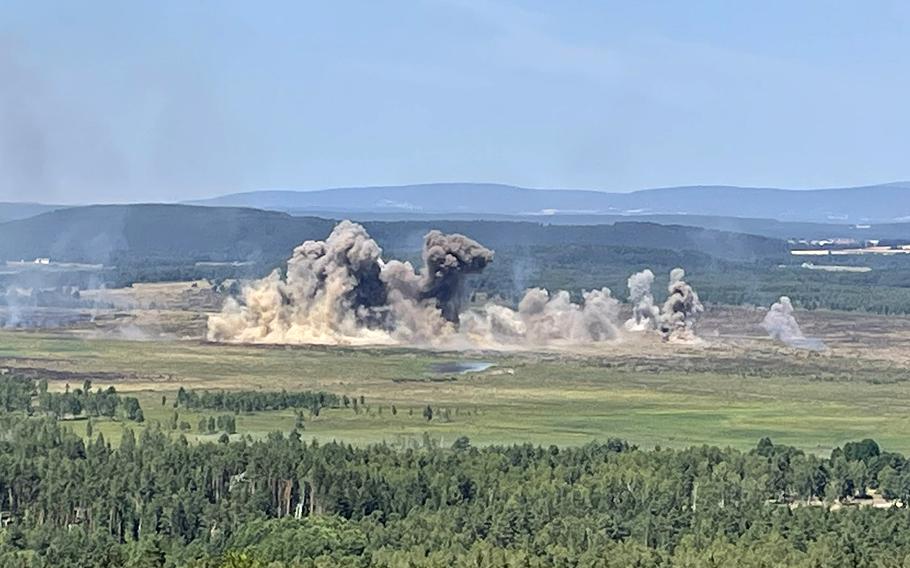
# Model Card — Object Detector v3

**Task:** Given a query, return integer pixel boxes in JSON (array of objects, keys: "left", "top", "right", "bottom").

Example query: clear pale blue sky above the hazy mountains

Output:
[{"left": 0, "top": 0, "right": 910, "bottom": 203}]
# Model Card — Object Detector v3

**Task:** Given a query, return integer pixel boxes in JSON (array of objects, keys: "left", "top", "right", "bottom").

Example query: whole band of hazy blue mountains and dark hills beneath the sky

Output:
[{"left": 0, "top": 183, "right": 910, "bottom": 265}]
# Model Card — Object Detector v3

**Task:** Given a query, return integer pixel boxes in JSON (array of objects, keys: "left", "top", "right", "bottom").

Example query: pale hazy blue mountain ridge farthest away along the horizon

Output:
[{"left": 183, "top": 182, "right": 910, "bottom": 224}]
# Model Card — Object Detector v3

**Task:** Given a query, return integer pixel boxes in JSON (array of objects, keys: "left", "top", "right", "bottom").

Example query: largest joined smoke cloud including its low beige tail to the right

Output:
[{"left": 208, "top": 221, "right": 636, "bottom": 347}]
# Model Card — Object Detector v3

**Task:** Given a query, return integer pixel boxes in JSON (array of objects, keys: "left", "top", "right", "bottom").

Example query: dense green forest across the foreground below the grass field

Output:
[{"left": 0, "top": 406, "right": 910, "bottom": 568}]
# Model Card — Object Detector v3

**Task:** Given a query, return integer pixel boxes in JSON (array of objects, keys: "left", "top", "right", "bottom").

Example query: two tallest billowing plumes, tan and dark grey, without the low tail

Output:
[{"left": 208, "top": 221, "right": 493, "bottom": 343}]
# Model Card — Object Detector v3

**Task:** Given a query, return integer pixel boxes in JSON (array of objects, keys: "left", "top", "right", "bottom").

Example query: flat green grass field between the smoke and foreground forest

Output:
[{"left": 0, "top": 332, "right": 910, "bottom": 453}]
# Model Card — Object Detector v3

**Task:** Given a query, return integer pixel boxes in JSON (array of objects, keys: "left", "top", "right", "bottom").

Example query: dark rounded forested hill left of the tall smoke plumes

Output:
[{"left": 0, "top": 204, "right": 333, "bottom": 264}]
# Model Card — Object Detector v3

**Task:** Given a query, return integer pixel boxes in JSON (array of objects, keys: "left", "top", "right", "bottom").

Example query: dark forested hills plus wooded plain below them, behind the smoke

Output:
[{"left": 0, "top": 204, "right": 910, "bottom": 313}]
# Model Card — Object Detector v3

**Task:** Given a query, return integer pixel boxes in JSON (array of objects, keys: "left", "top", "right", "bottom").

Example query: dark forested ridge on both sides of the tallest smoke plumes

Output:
[{"left": 0, "top": 205, "right": 786, "bottom": 264}]
